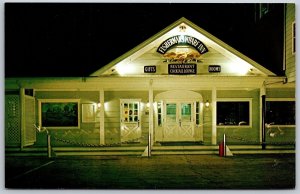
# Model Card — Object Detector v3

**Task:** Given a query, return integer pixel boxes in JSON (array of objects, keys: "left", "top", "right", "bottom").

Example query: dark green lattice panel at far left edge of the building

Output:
[{"left": 5, "top": 95, "right": 21, "bottom": 145}]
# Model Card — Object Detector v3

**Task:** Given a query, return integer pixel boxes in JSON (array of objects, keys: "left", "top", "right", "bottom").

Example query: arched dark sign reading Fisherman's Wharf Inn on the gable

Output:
[{"left": 157, "top": 35, "right": 208, "bottom": 54}]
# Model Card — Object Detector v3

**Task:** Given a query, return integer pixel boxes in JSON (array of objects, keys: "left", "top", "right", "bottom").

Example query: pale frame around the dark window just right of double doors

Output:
[{"left": 216, "top": 98, "right": 253, "bottom": 128}]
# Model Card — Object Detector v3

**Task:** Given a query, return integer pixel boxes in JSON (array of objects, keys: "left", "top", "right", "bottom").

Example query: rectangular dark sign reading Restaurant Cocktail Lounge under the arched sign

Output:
[{"left": 168, "top": 64, "right": 197, "bottom": 75}]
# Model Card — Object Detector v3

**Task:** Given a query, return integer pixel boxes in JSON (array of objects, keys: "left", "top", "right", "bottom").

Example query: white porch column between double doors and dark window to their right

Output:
[{"left": 211, "top": 87, "right": 217, "bottom": 145}]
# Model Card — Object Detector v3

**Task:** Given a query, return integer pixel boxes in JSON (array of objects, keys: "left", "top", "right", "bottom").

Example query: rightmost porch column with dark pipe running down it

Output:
[{"left": 259, "top": 86, "right": 266, "bottom": 149}]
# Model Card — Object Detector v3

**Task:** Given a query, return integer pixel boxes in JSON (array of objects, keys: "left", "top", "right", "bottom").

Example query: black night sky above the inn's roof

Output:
[{"left": 5, "top": 3, "right": 283, "bottom": 77}]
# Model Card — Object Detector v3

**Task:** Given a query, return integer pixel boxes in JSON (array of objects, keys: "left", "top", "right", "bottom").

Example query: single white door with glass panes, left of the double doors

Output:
[{"left": 121, "top": 100, "right": 142, "bottom": 142}]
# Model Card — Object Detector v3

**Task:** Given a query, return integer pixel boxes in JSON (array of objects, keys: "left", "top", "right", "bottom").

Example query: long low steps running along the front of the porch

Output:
[{"left": 5, "top": 145, "right": 296, "bottom": 157}]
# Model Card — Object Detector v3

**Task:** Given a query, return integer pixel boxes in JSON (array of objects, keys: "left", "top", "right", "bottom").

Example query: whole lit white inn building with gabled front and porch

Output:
[{"left": 5, "top": 10, "right": 295, "bottom": 156}]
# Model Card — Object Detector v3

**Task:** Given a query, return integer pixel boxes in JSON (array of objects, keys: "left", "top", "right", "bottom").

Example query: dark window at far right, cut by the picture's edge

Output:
[{"left": 266, "top": 99, "right": 295, "bottom": 125}]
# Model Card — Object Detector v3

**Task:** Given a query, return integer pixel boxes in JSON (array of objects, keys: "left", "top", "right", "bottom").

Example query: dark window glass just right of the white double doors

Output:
[{"left": 217, "top": 100, "right": 251, "bottom": 126}]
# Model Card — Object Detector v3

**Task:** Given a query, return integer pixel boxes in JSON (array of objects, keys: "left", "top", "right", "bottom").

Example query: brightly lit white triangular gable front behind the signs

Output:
[{"left": 90, "top": 17, "right": 275, "bottom": 76}]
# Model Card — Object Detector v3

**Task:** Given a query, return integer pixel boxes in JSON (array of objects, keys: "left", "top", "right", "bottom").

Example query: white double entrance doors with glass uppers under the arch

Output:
[{"left": 163, "top": 102, "right": 195, "bottom": 141}]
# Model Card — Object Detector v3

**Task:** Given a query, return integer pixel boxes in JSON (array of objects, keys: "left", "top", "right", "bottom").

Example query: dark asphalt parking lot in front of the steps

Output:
[{"left": 5, "top": 154, "right": 296, "bottom": 190}]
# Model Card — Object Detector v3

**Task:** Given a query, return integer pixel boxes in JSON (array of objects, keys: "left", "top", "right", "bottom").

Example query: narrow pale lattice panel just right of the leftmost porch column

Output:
[{"left": 24, "top": 96, "right": 36, "bottom": 145}]
